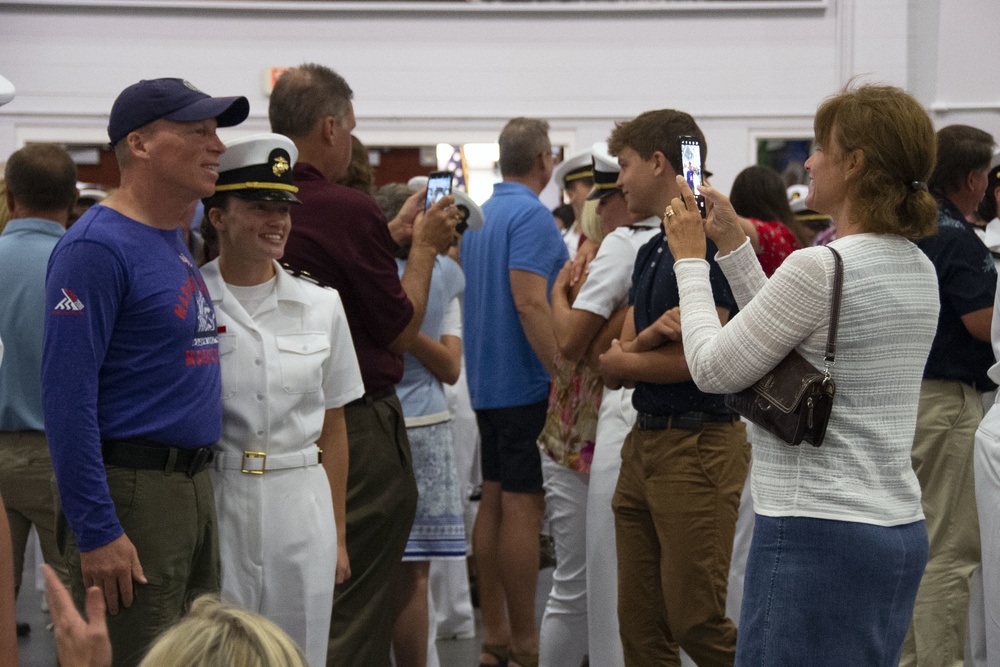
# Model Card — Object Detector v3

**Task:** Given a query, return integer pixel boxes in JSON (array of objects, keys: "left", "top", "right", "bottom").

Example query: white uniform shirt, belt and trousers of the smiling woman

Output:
[{"left": 201, "top": 260, "right": 364, "bottom": 667}]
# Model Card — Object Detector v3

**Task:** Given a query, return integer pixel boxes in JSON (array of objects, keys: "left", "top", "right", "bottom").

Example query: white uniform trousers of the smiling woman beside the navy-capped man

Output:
[{"left": 211, "top": 465, "right": 337, "bottom": 667}]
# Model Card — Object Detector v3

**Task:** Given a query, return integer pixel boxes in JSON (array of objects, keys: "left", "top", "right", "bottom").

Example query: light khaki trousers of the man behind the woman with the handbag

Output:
[{"left": 899, "top": 380, "right": 983, "bottom": 667}]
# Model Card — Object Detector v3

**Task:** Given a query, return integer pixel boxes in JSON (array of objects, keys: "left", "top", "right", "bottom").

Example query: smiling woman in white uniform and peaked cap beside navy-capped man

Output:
[{"left": 202, "top": 134, "right": 364, "bottom": 667}]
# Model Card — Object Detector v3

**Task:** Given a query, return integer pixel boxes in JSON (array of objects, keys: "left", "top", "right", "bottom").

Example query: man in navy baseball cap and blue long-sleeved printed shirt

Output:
[{"left": 42, "top": 79, "right": 249, "bottom": 665}]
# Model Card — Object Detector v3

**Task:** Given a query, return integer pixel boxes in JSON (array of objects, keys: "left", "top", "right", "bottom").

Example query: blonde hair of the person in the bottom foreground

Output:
[{"left": 139, "top": 595, "right": 307, "bottom": 667}]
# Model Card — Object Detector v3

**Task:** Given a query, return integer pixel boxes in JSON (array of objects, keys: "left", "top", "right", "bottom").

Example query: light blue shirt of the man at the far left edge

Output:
[{"left": 0, "top": 218, "right": 65, "bottom": 431}]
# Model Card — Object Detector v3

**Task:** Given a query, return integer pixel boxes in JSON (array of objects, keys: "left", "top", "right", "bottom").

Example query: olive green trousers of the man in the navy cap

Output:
[{"left": 57, "top": 465, "right": 219, "bottom": 667}]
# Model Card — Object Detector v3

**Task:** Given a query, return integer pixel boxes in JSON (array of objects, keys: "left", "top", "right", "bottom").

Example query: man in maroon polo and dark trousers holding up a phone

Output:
[{"left": 268, "top": 64, "right": 458, "bottom": 665}]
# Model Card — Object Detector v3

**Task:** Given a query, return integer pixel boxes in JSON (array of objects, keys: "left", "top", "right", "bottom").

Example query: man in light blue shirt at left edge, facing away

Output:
[{"left": 0, "top": 144, "right": 77, "bottom": 631}]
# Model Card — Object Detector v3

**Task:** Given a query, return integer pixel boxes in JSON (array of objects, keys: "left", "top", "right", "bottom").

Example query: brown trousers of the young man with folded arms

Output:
[{"left": 612, "top": 422, "right": 750, "bottom": 667}]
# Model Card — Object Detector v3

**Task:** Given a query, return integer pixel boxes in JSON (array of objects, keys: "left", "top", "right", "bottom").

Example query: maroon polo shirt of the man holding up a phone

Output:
[{"left": 282, "top": 162, "right": 413, "bottom": 394}]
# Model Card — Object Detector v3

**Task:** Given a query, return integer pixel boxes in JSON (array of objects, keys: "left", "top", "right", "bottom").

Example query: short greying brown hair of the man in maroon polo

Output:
[{"left": 267, "top": 63, "right": 354, "bottom": 139}]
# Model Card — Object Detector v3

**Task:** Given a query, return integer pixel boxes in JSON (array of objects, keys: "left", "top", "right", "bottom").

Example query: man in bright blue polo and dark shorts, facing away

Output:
[{"left": 461, "top": 118, "right": 569, "bottom": 667}]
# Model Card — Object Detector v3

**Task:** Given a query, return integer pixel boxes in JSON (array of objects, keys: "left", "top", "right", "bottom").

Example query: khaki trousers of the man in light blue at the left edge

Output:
[{"left": 0, "top": 431, "right": 69, "bottom": 595}]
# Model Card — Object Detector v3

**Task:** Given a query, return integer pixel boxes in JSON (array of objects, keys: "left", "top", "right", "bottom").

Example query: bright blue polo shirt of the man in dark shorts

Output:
[{"left": 461, "top": 181, "right": 569, "bottom": 410}]
